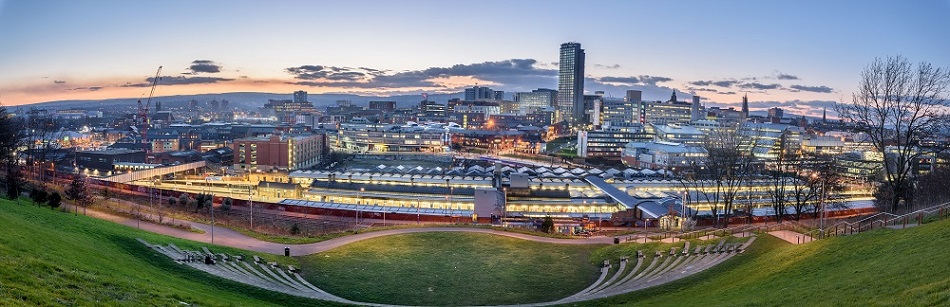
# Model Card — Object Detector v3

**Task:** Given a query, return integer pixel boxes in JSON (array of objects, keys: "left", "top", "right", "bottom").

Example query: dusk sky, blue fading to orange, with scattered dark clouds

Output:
[{"left": 0, "top": 0, "right": 950, "bottom": 115}]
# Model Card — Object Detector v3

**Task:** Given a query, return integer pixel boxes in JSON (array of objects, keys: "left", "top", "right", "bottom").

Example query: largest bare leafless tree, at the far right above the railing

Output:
[{"left": 836, "top": 55, "right": 950, "bottom": 211}]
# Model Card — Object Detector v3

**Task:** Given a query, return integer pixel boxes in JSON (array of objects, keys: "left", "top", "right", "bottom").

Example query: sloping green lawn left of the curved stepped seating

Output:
[{"left": 0, "top": 199, "right": 342, "bottom": 306}]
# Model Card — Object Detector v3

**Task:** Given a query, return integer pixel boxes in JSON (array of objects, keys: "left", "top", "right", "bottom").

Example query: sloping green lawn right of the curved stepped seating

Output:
[{"left": 585, "top": 220, "right": 950, "bottom": 306}]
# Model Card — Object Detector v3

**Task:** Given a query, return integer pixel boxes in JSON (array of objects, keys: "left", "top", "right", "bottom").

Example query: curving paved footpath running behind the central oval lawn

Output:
[{"left": 70, "top": 206, "right": 614, "bottom": 256}]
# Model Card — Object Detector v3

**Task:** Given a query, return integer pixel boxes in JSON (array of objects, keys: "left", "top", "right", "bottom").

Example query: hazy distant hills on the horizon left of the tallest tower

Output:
[{"left": 21, "top": 92, "right": 464, "bottom": 110}]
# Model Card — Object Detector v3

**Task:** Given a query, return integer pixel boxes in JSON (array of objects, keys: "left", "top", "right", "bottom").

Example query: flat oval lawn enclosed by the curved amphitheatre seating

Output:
[{"left": 300, "top": 233, "right": 601, "bottom": 306}]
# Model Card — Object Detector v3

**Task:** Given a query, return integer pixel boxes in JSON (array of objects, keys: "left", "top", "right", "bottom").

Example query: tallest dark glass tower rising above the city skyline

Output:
[{"left": 557, "top": 42, "right": 584, "bottom": 126}]
